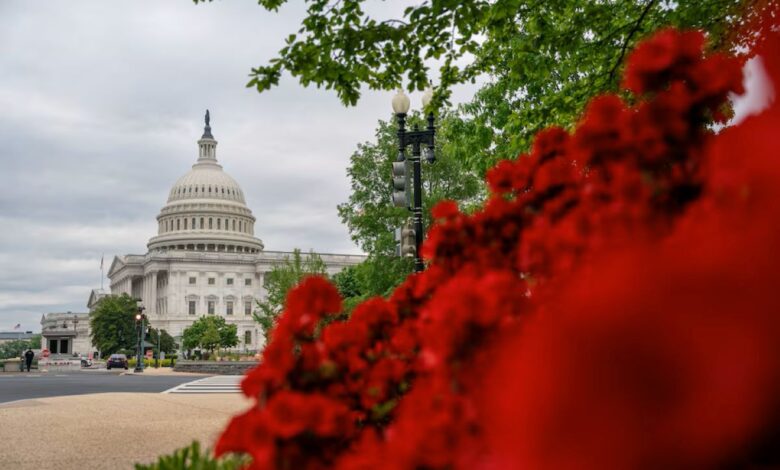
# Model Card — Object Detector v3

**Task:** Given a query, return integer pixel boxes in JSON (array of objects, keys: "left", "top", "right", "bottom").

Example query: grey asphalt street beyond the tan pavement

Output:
[{"left": 0, "top": 370, "right": 203, "bottom": 403}]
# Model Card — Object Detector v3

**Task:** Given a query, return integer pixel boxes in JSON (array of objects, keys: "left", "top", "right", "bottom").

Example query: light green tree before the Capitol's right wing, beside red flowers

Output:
[{"left": 253, "top": 248, "right": 327, "bottom": 341}]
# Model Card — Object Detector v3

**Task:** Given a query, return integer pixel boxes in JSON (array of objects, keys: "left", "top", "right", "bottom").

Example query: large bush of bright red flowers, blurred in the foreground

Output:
[{"left": 216, "top": 23, "right": 780, "bottom": 469}]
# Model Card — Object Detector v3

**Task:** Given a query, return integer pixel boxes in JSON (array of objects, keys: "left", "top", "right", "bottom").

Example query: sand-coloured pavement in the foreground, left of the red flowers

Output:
[{"left": 0, "top": 393, "right": 251, "bottom": 470}]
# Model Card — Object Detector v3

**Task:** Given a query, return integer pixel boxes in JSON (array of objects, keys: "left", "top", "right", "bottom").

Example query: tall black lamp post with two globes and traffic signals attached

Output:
[{"left": 393, "top": 88, "right": 436, "bottom": 272}]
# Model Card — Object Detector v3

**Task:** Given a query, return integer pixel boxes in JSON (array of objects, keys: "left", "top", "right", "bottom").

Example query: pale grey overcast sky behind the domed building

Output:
[{"left": 0, "top": 0, "right": 772, "bottom": 331}]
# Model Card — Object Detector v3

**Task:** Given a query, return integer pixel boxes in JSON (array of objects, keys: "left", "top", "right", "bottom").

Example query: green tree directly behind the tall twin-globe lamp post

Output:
[{"left": 334, "top": 114, "right": 484, "bottom": 302}]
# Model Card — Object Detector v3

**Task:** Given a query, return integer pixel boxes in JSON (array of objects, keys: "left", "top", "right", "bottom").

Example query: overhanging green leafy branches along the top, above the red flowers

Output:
[{"left": 195, "top": 0, "right": 748, "bottom": 173}]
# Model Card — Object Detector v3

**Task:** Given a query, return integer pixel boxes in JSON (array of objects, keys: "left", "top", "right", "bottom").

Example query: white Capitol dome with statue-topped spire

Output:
[{"left": 147, "top": 111, "right": 263, "bottom": 253}]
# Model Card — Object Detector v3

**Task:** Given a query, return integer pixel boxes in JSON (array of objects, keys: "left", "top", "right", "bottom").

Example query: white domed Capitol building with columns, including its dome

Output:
[{"left": 41, "top": 111, "right": 365, "bottom": 355}]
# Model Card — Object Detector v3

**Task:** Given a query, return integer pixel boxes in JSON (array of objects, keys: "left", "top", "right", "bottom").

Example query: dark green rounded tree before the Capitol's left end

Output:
[{"left": 89, "top": 294, "right": 138, "bottom": 357}]
